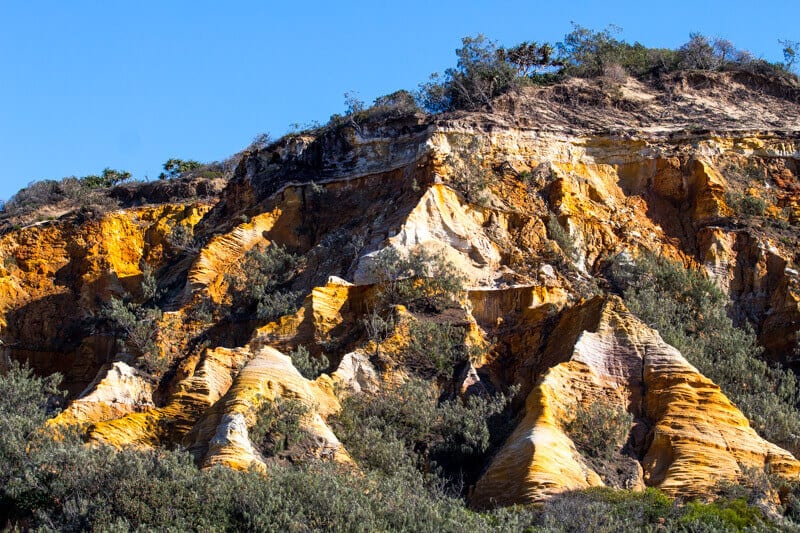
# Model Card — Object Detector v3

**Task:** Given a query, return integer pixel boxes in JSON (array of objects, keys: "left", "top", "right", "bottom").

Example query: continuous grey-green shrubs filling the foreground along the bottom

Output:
[{"left": 0, "top": 365, "right": 788, "bottom": 532}]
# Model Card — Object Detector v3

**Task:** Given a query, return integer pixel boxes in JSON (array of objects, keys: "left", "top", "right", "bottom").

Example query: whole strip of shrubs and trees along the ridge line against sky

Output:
[{"left": 0, "top": 24, "right": 800, "bottom": 220}]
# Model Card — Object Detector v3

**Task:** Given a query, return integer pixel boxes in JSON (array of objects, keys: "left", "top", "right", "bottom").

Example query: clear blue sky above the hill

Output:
[{"left": 0, "top": 0, "right": 800, "bottom": 198}]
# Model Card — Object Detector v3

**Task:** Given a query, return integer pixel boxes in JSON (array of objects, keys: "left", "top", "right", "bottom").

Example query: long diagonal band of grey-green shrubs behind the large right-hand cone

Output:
[{"left": 609, "top": 254, "right": 800, "bottom": 454}]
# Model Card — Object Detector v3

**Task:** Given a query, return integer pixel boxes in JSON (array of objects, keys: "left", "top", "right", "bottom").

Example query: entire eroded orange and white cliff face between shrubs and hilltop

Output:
[{"left": 0, "top": 72, "right": 800, "bottom": 507}]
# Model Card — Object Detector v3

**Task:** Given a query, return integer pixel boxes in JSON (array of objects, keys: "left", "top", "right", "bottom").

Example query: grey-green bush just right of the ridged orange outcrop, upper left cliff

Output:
[{"left": 225, "top": 244, "right": 304, "bottom": 320}]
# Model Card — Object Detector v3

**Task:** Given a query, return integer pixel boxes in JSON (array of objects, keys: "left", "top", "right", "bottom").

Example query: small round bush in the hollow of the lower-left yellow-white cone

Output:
[{"left": 249, "top": 396, "right": 308, "bottom": 457}]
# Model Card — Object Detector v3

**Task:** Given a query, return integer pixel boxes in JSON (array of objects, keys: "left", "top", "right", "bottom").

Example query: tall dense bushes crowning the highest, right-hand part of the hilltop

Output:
[{"left": 418, "top": 25, "right": 798, "bottom": 113}]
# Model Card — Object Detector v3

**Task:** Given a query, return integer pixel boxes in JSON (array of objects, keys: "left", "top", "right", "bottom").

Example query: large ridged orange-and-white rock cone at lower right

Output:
[{"left": 473, "top": 298, "right": 800, "bottom": 507}]
